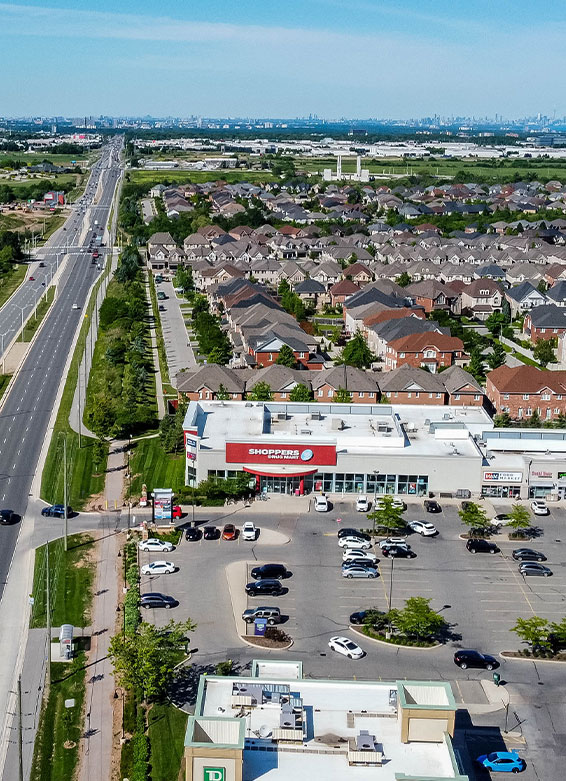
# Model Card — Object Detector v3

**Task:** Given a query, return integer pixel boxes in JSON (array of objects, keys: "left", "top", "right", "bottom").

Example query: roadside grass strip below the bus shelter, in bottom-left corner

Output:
[{"left": 30, "top": 653, "right": 86, "bottom": 781}]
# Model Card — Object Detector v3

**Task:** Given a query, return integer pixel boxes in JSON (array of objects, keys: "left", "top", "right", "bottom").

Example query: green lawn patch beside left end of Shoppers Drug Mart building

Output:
[{"left": 130, "top": 437, "right": 185, "bottom": 496}]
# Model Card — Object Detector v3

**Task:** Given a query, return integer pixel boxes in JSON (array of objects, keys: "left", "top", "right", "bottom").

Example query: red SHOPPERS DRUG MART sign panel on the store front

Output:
[{"left": 226, "top": 442, "right": 336, "bottom": 466}]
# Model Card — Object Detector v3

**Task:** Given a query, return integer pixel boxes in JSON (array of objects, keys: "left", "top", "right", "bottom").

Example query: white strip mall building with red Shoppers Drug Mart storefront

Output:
[{"left": 184, "top": 401, "right": 566, "bottom": 499}]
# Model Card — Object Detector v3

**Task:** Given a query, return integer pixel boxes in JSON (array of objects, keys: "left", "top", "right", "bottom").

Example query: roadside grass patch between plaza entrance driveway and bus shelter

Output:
[{"left": 30, "top": 532, "right": 95, "bottom": 629}]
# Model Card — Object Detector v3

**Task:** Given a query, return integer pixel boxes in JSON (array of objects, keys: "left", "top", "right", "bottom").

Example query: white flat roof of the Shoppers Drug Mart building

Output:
[{"left": 184, "top": 401, "right": 493, "bottom": 458}]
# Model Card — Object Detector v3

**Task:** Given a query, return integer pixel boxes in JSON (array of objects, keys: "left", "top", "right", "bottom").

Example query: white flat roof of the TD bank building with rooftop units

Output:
[{"left": 196, "top": 676, "right": 464, "bottom": 781}]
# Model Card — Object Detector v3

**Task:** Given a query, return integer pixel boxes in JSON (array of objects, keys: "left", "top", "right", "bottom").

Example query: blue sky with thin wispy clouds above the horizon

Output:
[{"left": 0, "top": 0, "right": 566, "bottom": 119}]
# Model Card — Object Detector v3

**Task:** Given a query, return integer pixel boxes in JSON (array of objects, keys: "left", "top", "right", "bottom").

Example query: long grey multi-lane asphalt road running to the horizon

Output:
[{"left": 0, "top": 140, "right": 120, "bottom": 595}]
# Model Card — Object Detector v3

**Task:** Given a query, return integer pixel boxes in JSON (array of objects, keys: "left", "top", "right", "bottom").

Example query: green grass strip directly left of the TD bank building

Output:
[{"left": 148, "top": 704, "right": 187, "bottom": 781}]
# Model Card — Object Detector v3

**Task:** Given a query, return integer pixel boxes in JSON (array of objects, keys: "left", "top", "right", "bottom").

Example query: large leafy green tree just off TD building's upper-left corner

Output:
[{"left": 108, "top": 618, "right": 196, "bottom": 701}]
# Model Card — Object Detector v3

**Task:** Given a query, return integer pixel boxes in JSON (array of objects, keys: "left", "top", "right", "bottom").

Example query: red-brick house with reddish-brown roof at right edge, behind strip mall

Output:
[{"left": 486, "top": 366, "right": 566, "bottom": 420}]
